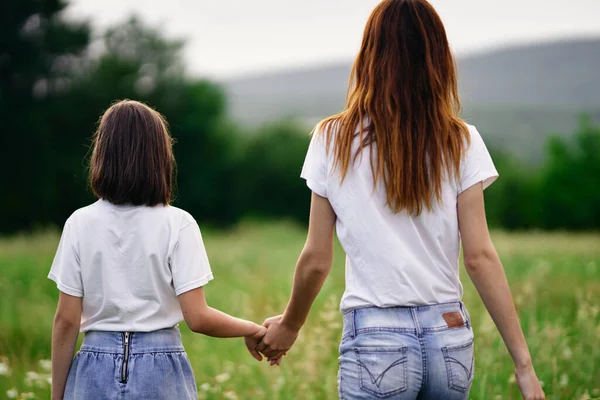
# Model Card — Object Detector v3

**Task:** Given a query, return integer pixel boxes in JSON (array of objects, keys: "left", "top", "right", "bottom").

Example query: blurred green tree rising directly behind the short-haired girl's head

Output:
[{"left": 55, "top": 18, "right": 233, "bottom": 223}]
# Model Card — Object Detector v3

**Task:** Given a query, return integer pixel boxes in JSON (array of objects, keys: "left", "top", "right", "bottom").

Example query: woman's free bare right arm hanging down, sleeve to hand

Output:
[{"left": 458, "top": 183, "right": 544, "bottom": 399}]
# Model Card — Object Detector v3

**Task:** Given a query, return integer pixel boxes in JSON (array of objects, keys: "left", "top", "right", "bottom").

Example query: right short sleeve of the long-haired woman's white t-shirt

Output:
[{"left": 458, "top": 126, "right": 498, "bottom": 194}]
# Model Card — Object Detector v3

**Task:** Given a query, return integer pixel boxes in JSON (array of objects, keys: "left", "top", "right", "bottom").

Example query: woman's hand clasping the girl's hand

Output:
[{"left": 256, "top": 315, "right": 298, "bottom": 365}]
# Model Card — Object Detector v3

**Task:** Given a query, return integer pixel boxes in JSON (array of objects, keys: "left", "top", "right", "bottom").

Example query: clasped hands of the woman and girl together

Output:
[{"left": 246, "top": 315, "right": 298, "bottom": 365}]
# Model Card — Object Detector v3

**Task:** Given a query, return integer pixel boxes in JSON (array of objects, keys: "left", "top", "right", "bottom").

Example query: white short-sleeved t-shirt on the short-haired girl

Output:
[{"left": 48, "top": 200, "right": 213, "bottom": 332}]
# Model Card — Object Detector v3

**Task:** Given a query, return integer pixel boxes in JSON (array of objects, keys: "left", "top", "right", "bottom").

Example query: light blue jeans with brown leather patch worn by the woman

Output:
[{"left": 338, "top": 302, "right": 474, "bottom": 400}]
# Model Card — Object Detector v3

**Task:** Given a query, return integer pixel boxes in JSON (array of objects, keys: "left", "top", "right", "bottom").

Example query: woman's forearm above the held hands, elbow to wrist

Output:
[{"left": 281, "top": 250, "right": 333, "bottom": 330}]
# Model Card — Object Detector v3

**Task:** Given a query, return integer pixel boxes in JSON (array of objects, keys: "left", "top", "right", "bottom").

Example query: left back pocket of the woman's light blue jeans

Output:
[{"left": 354, "top": 347, "right": 408, "bottom": 399}]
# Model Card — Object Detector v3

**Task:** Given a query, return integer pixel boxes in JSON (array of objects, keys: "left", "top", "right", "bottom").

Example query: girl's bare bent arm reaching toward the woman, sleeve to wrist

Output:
[{"left": 179, "top": 288, "right": 263, "bottom": 338}]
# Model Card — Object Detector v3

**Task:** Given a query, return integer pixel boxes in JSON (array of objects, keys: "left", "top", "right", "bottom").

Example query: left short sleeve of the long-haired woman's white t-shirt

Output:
[{"left": 300, "top": 127, "right": 328, "bottom": 197}]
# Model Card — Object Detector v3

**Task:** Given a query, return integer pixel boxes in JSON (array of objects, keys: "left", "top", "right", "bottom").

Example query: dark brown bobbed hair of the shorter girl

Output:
[{"left": 90, "top": 100, "right": 175, "bottom": 206}]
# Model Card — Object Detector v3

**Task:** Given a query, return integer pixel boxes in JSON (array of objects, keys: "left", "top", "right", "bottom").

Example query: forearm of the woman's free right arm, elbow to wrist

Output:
[{"left": 465, "top": 251, "right": 531, "bottom": 368}]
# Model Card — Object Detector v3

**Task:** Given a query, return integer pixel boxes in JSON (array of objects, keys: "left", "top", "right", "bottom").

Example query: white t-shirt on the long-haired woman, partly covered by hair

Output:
[{"left": 301, "top": 122, "right": 498, "bottom": 312}]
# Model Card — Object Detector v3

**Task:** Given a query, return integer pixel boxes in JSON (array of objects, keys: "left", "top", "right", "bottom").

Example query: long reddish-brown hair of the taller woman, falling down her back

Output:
[{"left": 321, "top": 0, "right": 469, "bottom": 215}]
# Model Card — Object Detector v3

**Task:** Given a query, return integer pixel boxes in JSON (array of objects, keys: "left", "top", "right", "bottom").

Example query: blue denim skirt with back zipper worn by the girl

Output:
[{"left": 64, "top": 327, "right": 198, "bottom": 400}]
